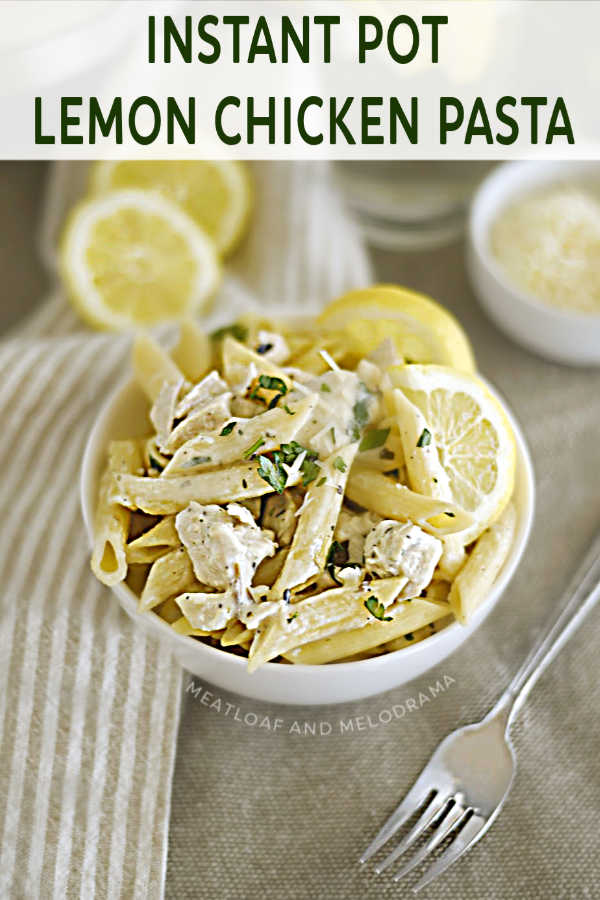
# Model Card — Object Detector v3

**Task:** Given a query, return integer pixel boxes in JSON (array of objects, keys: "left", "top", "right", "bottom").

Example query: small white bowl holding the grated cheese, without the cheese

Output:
[{"left": 467, "top": 162, "right": 600, "bottom": 366}]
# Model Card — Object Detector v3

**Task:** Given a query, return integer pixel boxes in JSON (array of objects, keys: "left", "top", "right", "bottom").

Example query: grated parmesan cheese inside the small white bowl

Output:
[{"left": 491, "top": 185, "right": 600, "bottom": 314}]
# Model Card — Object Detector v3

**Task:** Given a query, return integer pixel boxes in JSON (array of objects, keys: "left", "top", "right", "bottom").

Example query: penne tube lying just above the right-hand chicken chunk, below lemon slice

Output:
[{"left": 346, "top": 466, "right": 473, "bottom": 537}]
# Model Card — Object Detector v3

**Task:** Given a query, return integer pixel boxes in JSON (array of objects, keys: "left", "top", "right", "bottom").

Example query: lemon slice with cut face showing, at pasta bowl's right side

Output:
[{"left": 390, "top": 365, "right": 516, "bottom": 540}]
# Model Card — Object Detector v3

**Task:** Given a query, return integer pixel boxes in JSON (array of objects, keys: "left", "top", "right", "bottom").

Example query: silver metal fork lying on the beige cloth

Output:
[{"left": 360, "top": 535, "right": 600, "bottom": 893}]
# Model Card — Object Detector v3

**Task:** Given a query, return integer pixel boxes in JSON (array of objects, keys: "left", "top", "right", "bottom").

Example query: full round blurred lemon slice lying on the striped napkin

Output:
[{"left": 60, "top": 190, "right": 220, "bottom": 330}]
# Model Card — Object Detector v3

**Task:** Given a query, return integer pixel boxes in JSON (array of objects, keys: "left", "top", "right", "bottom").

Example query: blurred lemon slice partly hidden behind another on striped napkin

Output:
[{"left": 90, "top": 160, "right": 252, "bottom": 256}]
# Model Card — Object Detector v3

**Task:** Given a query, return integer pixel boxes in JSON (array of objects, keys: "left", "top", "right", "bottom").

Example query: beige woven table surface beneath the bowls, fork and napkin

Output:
[{"left": 0, "top": 163, "right": 600, "bottom": 900}]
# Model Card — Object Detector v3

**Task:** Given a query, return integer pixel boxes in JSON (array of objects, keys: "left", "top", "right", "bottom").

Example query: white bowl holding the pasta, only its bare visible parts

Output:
[{"left": 81, "top": 381, "right": 534, "bottom": 705}]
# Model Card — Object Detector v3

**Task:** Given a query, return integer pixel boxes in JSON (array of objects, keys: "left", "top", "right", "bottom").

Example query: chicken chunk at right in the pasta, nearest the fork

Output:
[{"left": 365, "top": 519, "right": 442, "bottom": 597}]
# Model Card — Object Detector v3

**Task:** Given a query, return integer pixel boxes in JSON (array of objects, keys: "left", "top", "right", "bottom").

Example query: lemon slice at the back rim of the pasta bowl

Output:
[{"left": 319, "top": 284, "right": 475, "bottom": 372}]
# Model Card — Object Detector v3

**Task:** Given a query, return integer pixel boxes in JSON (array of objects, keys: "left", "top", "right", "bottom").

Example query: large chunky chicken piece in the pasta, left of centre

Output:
[{"left": 175, "top": 501, "right": 276, "bottom": 603}]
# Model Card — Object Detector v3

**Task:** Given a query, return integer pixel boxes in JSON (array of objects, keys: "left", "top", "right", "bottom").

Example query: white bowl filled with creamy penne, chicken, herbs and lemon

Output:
[{"left": 82, "top": 292, "right": 533, "bottom": 703}]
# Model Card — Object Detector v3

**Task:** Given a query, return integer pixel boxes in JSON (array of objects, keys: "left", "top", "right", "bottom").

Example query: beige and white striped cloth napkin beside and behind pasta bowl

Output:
[{"left": 0, "top": 163, "right": 370, "bottom": 900}]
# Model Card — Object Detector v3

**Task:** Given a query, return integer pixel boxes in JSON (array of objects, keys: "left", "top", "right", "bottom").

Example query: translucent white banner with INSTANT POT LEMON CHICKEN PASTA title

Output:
[{"left": 0, "top": 0, "right": 600, "bottom": 160}]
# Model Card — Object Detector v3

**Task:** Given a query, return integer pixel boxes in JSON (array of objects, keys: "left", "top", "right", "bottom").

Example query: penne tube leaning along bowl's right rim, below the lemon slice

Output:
[{"left": 448, "top": 503, "right": 517, "bottom": 625}]
